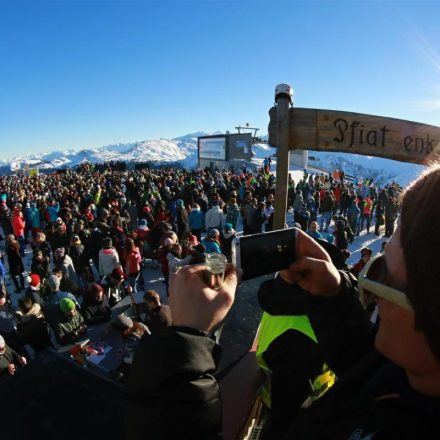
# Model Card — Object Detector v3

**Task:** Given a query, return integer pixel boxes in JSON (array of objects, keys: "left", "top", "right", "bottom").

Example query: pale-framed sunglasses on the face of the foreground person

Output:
[{"left": 358, "top": 255, "right": 414, "bottom": 312}]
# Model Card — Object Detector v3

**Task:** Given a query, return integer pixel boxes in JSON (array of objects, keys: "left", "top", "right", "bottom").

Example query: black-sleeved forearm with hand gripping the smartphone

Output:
[{"left": 280, "top": 227, "right": 374, "bottom": 374}]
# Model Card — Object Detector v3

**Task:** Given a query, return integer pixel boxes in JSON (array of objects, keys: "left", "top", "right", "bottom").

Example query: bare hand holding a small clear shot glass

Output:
[{"left": 169, "top": 264, "right": 237, "bottom": 332}]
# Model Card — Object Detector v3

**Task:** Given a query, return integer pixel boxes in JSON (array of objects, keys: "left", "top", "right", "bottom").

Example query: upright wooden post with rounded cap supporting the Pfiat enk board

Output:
[{"left": 273, "top": 84, "right": 293, "bottom": 230}]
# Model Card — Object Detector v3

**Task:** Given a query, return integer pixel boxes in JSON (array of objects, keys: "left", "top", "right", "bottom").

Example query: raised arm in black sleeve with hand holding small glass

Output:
[{"left": 126, "top": 266, "right": 237, "bottom": 440}]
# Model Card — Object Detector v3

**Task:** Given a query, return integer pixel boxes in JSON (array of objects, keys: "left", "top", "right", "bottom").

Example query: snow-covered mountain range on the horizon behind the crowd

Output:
[{"left": 0, "top": 132, "right": 423, "bottom": 185}]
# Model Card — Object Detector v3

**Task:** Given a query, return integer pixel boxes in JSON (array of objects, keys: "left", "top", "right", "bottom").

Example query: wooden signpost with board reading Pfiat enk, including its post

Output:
[{"left": 268, "top": 84, "right": 440, "bottom": 229}]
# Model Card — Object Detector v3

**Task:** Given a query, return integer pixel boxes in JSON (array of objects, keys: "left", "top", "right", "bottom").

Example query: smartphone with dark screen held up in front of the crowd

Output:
[{"left": 232, "top": 228, "right": 297, "bottom": 281}]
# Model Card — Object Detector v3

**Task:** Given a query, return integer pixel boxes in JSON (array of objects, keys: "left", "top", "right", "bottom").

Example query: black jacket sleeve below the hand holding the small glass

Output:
[{"left": 125, "top": 327, "right": 221, "bottom": 440}]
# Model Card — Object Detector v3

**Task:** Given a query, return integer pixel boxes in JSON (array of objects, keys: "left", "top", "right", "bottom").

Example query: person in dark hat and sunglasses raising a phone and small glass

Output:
[{"left": 126, "top": 164, "right": 440, "bottom": 440}]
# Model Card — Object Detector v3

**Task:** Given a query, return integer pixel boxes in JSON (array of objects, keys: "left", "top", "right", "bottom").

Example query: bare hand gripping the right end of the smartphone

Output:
[{"left": 280, "top": 231, "right": 341, "bottom": 296}]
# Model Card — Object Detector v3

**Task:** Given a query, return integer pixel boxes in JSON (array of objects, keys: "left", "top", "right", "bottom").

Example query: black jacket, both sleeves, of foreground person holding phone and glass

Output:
[{"left": 122, "top": 275, "right": 440, "bottom": 440}]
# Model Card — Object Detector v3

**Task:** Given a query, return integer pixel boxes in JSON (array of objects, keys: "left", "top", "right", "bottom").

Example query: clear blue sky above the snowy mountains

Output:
[{"left": 0, "top": 0, "right": 440, "bottom": 158}]
